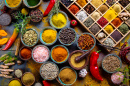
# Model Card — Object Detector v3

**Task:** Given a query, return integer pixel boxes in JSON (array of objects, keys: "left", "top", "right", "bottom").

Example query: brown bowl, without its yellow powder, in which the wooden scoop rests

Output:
[{"left": 68, "top": 50, "right": 88, "bottom": 70}]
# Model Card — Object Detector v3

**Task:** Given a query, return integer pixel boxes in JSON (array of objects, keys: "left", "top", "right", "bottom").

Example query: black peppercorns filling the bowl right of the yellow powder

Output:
[{"left": 59, "top": 28, "right": 76, "bottom": 44}]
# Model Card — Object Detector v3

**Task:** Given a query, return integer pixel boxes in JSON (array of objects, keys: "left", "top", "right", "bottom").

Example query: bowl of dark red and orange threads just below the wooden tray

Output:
[{"left": 77, "top": 33, "right": 96, "bottom": 51}]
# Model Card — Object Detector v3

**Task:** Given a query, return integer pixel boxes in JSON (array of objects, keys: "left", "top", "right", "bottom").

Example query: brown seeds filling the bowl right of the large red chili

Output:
[{"left": 102, "top": 55, "right": 121, "bottom": 72}]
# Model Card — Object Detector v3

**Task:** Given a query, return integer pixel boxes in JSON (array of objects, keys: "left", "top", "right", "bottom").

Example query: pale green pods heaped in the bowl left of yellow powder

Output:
[{"left": 23, "top": 30, "right": 38, "bottom": 46}]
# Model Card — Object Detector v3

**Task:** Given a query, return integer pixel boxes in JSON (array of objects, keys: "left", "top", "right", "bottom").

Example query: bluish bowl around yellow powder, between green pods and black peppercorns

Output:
[{"left": 40, "top": 27, "right": 57, "bottom": 46}]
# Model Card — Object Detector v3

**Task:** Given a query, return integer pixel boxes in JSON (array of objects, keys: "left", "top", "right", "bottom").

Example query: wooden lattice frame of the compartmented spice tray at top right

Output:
[{"left": 60, "top": 0, "right": 130, "bottom": 51}]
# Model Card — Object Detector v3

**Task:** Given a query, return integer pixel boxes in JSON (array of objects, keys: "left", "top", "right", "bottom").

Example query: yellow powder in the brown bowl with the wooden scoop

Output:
[{"left": 70, "top": 52, "right": 86, "bottom": 68}]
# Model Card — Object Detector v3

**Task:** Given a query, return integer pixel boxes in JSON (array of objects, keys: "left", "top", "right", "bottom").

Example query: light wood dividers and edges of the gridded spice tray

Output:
[{"left": 60, "top": 0, "right": 130, "bottom": 51}]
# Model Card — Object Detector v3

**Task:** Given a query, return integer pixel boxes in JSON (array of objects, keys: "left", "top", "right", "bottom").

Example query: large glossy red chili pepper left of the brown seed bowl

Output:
[{"left": 90, "top": 51, "right": 103, "bottom": 81}]
